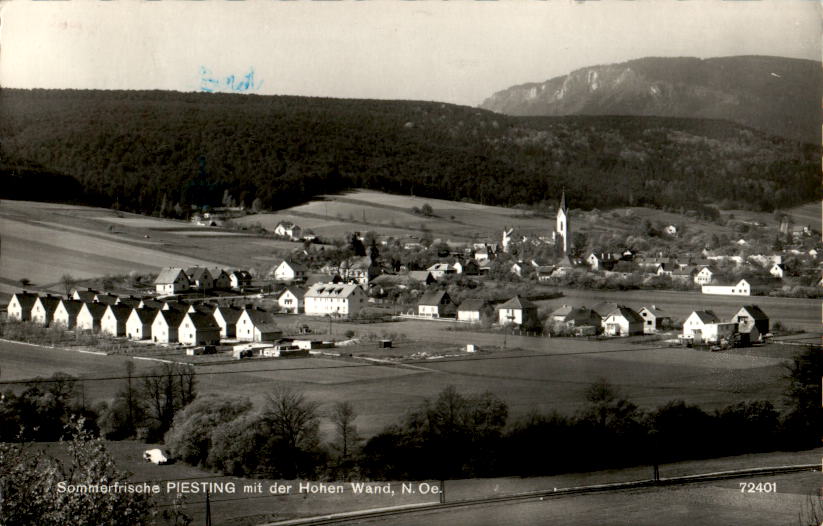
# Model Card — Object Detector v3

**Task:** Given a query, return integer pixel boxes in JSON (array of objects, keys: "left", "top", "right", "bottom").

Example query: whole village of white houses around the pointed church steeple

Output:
[{"left": 1, "top": 195, "right": 804, "bottom": 358}]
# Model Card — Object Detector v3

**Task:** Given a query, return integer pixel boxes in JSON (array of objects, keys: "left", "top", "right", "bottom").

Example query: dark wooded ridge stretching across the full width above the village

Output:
[{"left": 0, "top": 89, "right": 821, "bottom": 213}]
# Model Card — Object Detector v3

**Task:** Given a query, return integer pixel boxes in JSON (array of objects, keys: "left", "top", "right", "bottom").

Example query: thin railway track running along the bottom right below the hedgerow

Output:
[{"left": 260, "top": 464, "right": 821, "bottom": 526}]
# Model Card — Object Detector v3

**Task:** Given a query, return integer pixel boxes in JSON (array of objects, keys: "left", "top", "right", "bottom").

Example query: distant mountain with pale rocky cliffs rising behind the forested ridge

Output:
[{"left": 480, "top": 56, "right": 823, "bottom": 143}]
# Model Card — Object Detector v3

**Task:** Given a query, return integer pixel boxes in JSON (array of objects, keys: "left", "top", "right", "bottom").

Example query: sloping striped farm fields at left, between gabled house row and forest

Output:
[{"left": 0, "top": 200, "right": 302, "bottom": 295}]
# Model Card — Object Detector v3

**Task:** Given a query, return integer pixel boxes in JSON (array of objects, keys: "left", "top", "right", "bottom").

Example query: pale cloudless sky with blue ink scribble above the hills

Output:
[{"left": 0, "top": 0, "right": 822, "bottom": 106}]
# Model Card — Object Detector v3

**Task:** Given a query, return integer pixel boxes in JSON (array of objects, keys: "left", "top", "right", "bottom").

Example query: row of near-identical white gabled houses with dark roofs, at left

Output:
[{"left": 8, "top": 291, "right": 282, "bottom": 345}]
